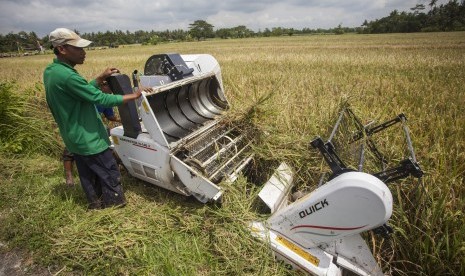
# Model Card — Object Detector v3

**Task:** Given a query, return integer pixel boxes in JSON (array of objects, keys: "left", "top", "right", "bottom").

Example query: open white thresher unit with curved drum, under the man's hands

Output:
[{"left": 109, "top": 54, "right": 288, "bottom": 203}]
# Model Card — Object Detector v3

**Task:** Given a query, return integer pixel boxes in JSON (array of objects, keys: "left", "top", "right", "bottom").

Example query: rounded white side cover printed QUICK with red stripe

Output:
[{"left": 268, "top": 172, "right": 392, "bottom": 247}]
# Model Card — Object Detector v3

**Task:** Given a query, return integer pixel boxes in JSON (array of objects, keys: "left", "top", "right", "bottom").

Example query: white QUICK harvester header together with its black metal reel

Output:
[{"left": 252, "top": 106, "right": 423, "bottom": 275}]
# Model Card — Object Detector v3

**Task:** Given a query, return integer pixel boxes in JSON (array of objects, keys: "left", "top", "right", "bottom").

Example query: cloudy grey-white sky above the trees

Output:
[{"left": 0, "top": 0, "right": 448, "bottom": 37}]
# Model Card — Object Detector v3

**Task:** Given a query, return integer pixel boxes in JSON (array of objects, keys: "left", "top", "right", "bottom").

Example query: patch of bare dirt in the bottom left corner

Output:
[{"left": 0, "top": 241, "right": 51, "bottom": 276}]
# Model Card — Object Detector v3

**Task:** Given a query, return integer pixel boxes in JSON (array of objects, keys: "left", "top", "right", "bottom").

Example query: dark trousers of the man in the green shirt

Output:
[{"left": 74, "top": 149, "right": 126, "bottom": 209}]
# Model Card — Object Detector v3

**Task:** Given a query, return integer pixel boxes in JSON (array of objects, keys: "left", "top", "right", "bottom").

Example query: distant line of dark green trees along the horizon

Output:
[{"left": 0, "top": 0, "right": 465, "bottom": 53}]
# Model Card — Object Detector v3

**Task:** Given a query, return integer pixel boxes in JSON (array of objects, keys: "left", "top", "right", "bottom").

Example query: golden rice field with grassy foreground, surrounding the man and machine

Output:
[{"left": 0, "top": 32, "right": 465, "bottom": 275}]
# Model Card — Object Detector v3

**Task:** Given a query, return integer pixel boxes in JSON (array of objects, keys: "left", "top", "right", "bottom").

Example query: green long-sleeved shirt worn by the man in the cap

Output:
[{"left": 44, "top": 59, "right": 123, "bottom": 155}]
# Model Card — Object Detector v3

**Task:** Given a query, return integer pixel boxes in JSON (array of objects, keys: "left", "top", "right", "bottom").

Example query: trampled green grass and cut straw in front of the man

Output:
[{"left": 0, "top": 156, "right": 292, "bottom": 275}]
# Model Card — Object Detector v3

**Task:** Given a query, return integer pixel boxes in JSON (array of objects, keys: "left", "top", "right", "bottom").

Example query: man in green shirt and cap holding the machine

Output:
[{"left": 44, "top": 28, "right": 152, "bottom": 209}]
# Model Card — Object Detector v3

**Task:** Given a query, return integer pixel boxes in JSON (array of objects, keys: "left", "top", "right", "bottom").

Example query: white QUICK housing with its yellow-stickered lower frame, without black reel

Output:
[{"left": 252, "top": 172, "right": 392, "bottom": 275}]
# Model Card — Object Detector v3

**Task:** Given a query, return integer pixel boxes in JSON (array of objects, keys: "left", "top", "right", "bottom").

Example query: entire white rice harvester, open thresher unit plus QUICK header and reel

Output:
[{"left": 108, "top": 54, "right": 422, "bottom": 275}]
